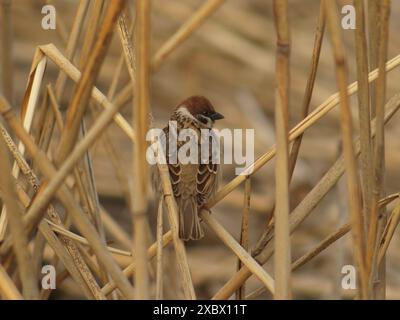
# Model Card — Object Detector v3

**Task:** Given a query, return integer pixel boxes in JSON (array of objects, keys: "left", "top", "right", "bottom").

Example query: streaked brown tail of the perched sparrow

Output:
[{"left": 178, "top": 197, "right": 204, "bottom": 241}]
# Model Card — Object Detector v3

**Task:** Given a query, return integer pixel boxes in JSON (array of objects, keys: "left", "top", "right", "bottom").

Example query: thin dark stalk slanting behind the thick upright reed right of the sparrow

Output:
[{"left": 253, "top": 1, "right": 326, "bottom": 255}]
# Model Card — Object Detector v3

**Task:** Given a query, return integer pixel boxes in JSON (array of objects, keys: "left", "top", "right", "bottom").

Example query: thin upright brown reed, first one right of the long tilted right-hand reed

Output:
[{"left": 354, "top": 0, "right": 374, "bottom": 230}]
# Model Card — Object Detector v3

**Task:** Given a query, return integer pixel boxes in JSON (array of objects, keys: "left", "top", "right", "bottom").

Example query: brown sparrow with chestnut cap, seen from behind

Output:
[{"left": 152, "top": 96, "right": 224, "bottom": 241}]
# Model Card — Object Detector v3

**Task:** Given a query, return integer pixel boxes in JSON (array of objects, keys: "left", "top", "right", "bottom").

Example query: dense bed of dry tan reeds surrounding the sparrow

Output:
[{"left": 0, "top": 0, "right": 400, "bottom": 300}]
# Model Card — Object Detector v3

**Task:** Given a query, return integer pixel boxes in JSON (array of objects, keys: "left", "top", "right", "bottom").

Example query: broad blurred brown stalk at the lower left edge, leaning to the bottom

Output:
[{"left": 0, "top": 134, "right": 39, "bottom": 299}]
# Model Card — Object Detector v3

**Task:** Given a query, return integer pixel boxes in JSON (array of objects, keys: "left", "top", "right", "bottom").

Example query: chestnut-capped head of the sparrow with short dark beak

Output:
[{"left": 177, "top": 96, "right": 224, "bottom": 128}]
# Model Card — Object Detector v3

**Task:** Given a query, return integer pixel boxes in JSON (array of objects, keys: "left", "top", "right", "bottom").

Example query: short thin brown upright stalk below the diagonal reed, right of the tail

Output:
[{"left": 236, "top": 178, "right": 251, "bottom": 300}]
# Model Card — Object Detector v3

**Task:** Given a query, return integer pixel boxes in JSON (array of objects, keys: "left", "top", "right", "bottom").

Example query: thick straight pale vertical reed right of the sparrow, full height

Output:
[{"left": 273, "top": 0, "right": 292, "bottom": 300}]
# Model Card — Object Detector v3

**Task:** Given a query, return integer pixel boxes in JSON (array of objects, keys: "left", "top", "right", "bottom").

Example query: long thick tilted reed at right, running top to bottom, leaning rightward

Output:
[{"left": 325, "top": 1, "right": 368, "bottom": 299}]
